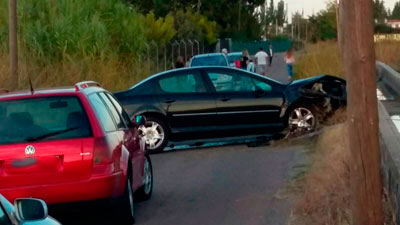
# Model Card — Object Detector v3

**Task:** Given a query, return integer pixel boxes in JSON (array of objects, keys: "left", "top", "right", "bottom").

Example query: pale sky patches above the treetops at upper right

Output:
[{"left": 284, "top": 0, "right": 398, "bottom": 18}]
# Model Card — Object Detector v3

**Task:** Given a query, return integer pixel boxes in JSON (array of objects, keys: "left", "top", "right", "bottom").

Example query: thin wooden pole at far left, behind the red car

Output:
[{"left": 7, "top": 0, "right": 18, "bottom": 90}]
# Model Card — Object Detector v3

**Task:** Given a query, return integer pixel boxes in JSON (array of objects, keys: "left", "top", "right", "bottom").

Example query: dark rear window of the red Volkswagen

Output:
[{"left": 0, "top": 96, "right": 92, "bottom": 145}]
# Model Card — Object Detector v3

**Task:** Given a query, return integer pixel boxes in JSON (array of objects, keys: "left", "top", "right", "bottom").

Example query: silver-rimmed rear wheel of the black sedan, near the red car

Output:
[{"left": 140, "top": 117, "right": 169, "bottom": 154}]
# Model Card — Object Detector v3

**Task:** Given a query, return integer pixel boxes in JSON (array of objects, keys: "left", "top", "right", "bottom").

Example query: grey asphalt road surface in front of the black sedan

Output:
[{"left": 50, "top": 145, "right": 304, "bottom": 225}]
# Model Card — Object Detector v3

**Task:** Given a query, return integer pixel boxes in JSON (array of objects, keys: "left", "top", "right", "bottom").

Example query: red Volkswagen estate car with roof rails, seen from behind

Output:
[{"left": 0, "top": 82, "right": 153, "bottom": 223}]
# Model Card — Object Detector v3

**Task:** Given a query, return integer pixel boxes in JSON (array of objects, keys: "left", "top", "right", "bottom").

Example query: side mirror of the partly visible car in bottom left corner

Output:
[{"left": 14, "top": 198, "right": 48, "bottom": 222}]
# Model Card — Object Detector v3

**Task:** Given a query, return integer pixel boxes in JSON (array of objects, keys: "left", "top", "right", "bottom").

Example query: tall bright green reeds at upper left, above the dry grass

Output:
[{"left": 0, "top": 0, "right": 146, "bottom": 60}]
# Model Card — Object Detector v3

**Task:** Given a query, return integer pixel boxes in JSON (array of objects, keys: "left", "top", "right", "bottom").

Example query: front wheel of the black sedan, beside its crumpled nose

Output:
[{"left": 286, "top": 105, "right": 320, "bottom": 137}]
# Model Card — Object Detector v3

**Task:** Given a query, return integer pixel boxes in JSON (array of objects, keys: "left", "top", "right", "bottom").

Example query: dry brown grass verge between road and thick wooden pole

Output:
[{"left": 289, "top": 123, "right": 395, "bottom": 225}]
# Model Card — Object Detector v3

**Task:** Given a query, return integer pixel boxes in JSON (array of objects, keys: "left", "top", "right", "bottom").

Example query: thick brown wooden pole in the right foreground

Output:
[{"left": 338, "top": 0, "right": 383, "bottom": 225}]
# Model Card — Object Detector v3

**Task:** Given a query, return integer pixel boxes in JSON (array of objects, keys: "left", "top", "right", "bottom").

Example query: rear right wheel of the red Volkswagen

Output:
[{"left": 114, "top": 175, "right": 135, "bottom": 224}]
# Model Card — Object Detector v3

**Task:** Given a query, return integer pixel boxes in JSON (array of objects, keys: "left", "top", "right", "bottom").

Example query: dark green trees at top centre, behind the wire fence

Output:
[{"left": 129, "top": 0, "right": 264, "bottom": 41}]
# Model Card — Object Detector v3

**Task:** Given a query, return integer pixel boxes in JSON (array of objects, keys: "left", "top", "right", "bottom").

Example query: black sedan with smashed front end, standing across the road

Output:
[{"left": 115, "top": 67, "right": 346, "bottom": 153}]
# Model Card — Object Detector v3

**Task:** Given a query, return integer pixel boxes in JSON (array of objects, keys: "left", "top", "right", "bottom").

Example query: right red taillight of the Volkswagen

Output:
[{"left": 93, "top": 138, "right": 115, "bottom": 175}]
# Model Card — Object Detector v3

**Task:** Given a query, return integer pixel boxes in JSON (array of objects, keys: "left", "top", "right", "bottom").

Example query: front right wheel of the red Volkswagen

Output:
[{"left": 135, "top": 155, "right": 153, "bottom": 202}]
